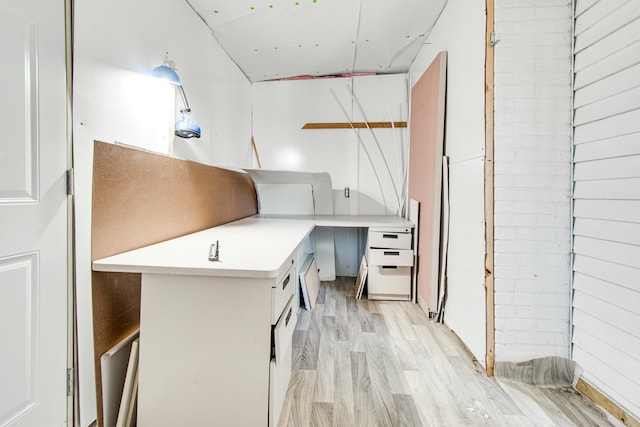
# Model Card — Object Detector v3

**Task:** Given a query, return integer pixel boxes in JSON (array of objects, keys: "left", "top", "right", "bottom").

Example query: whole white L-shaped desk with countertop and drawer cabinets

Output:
[{"left": 93, "top": 216, "right": 411, "bottom": 427}]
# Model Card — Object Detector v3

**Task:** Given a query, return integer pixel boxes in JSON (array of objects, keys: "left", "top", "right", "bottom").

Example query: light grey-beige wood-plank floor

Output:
[{"left": 279, "top": 278, "right": 613, "bottom": 427}]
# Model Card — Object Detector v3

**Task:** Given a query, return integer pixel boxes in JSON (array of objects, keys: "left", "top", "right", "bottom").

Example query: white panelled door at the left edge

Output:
[{"left": 0, "top": 0, "right": 67, "bottom": 427}]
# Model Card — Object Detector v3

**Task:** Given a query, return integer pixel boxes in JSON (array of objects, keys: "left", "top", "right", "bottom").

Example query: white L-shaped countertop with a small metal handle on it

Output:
[{"left": 93, "top": 215, "right": 413, "bottom": 278}]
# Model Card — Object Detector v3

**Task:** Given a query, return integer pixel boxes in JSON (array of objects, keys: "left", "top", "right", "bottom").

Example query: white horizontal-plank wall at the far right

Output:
[{"left": 572, "top": 0, "right": 640, "bottom": 418}]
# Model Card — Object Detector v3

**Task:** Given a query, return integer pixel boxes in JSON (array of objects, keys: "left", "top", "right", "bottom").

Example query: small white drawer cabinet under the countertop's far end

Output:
[{"left": 366, "top": 227, "right": 413, "bottom": 300}]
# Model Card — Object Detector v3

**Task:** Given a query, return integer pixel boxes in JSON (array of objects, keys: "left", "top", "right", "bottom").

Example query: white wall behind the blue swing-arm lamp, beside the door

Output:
[{"left": 73, "top": 0, "right": 253, "bottom": 427}]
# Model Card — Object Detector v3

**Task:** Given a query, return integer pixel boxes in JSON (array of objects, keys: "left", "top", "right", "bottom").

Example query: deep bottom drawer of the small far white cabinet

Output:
[{"left": 367, "top": 265, "right": 411, "bottom": 300}]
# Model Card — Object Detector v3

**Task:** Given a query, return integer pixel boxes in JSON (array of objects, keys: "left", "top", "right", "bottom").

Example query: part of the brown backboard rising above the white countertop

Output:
[{"left": 91, "top": 142, "right": 258, "bottom": 260}]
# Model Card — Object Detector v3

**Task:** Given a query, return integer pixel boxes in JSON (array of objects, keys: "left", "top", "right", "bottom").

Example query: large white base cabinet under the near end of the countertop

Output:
[{"left": 138, "top": 274, "right": 297, "bottom": 427}]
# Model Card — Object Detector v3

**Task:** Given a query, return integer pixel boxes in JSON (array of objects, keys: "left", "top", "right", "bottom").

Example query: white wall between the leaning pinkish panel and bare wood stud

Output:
[{"left": 410, "top": 0, "right": 486, "bottom": 363}]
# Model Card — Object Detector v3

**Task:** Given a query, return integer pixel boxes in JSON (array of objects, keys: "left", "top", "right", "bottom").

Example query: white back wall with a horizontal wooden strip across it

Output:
[{"left": 253, "top": 74, "right": 408, "bottom": 214}]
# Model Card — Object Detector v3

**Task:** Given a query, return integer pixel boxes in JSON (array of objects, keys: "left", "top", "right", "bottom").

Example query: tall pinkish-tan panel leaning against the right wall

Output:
[{"left": 409, "top": 52, "right": 447, "bottom": 312}]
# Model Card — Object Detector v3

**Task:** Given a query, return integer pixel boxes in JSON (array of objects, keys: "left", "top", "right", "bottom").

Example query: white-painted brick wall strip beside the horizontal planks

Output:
[{"left": 494, "top": 0, "right": 572, "bottom": 362}]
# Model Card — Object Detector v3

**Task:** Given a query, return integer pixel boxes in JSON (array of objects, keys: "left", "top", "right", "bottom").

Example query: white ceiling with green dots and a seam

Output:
[{"left": 187, "top": 0, "right": 447, "bottom": 82}]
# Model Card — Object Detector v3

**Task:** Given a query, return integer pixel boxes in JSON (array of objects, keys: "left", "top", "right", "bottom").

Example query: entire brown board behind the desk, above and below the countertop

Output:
[{"left": 91, "top": 141, "right": 258, "bottom": 425}]
